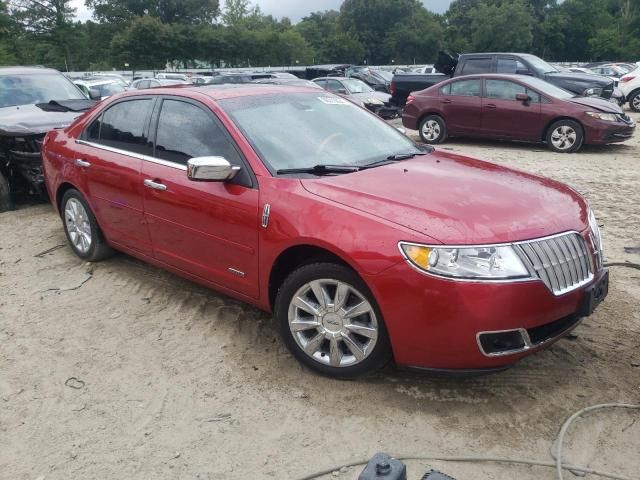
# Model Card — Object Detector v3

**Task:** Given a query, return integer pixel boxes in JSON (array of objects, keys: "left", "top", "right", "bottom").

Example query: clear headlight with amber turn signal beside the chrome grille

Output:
[{"left": 400, "top": 242, "right": 531, "bottom": 280}]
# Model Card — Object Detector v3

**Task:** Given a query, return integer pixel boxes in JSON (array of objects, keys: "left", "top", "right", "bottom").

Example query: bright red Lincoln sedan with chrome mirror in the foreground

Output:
[{"left": 43, "top": 85, "right": 608, "bottom": 378}]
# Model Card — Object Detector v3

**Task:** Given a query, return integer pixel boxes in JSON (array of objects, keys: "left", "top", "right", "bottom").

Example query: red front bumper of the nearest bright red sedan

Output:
[{"left": 367, "top": 262, "right": 607, "bottom": 372}]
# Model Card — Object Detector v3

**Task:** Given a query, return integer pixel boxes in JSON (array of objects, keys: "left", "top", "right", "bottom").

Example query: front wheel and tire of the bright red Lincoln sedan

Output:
[{"left": 274, "top": 263, "right": 391, "bottom": 379}]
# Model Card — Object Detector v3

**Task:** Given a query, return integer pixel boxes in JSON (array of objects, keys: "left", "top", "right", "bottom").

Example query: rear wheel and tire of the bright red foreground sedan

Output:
[{"left": 60, "top": 189, "right": 113, "bottom": 262}]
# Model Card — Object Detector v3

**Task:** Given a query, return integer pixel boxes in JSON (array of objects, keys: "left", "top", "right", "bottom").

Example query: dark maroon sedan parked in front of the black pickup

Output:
[{"left": 402, "top": 75, "right": 635, "bottom": 153}]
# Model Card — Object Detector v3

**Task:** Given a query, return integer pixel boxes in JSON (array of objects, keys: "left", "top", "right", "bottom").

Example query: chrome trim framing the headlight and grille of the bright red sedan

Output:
[{"left": 397, "top": 230, "right": 595, "bottom": 297}]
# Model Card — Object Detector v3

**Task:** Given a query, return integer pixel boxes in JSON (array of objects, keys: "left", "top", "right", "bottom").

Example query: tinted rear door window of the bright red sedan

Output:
[{"left": 85, "top": 98, "right": 153, "bottom": 155}]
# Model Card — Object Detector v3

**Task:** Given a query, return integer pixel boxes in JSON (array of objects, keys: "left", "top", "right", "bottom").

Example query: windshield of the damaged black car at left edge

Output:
[{"left": 0, "top": 73, "right": 87, "bottom": 108}]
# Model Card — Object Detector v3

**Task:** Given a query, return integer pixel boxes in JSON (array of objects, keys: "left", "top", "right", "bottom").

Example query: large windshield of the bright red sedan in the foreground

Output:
[{"left": 219, "top": 92, "right": 424, "bottom": 173}]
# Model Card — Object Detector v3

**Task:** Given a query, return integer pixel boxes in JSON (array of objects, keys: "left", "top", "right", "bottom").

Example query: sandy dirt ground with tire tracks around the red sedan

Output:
[{"left": 0, "top": 109, "right": 640, "bottom": 480}]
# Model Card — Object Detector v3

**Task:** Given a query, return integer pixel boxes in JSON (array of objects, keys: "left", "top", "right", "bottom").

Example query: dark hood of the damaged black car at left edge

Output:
[{"left": 0, "top": 105, "right": 84, "bottom": 135}]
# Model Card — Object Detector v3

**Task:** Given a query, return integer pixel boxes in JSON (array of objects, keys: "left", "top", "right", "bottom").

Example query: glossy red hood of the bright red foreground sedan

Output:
[{"left": 301, "top": 152, "right": 588, "bottom": 245}]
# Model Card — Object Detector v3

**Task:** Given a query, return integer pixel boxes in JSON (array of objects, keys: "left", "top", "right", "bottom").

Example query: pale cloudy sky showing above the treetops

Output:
[{"left": 71, "top": 0, "right": 451, "bottom": 22}]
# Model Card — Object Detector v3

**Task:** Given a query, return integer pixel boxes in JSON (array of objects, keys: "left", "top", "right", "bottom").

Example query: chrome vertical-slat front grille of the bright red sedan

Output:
[{"left": 516, "top": 233, "right": 597, "bottom": 295}]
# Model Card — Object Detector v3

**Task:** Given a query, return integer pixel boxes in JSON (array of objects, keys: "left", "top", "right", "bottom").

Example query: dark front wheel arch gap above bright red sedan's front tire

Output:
[{"left": 268, "top": 243, "right": 362, "bottom": 309}]
